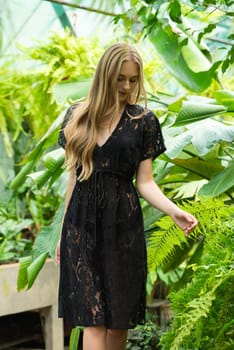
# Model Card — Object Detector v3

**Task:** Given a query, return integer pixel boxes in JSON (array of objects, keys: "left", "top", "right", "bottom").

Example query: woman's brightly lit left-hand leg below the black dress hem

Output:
[{"left": 83, "top": 327, "right": 106, "bottom": 350}]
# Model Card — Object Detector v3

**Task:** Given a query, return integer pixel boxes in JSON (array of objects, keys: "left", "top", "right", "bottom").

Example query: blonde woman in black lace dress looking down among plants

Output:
[{"left": 56, "top": 43, "right": 197, "bottom": 350}]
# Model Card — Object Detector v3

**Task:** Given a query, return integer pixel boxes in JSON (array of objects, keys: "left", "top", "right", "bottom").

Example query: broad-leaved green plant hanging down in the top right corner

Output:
[{"left": 116, "top": 0, "right": 234, "bottom": 92}]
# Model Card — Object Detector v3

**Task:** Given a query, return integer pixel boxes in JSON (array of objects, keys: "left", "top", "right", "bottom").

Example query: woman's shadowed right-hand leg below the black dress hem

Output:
[{"left": 106, "top": 329, "right": 128, "bottom": 350}]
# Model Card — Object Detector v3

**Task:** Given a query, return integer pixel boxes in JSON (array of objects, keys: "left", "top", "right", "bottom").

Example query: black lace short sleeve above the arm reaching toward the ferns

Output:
[{"left": 141, "top": 111, "right": 166, "bottom": 160}]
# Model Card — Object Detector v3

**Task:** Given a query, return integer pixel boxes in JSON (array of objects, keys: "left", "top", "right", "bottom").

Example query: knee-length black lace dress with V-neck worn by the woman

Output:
[{"left": 59, "top": 105, "right": 165, "bottom": 329}]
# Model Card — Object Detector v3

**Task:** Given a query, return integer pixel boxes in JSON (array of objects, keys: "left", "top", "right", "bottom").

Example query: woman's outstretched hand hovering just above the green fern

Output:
[{"left": 171, "top": 208, "right": 198, "bottom": 236}]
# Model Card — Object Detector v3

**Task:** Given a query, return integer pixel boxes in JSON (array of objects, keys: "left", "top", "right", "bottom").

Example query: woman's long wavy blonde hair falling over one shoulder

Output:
[{"left": 64, "top": 43, "right": 146, "bottom": 181}]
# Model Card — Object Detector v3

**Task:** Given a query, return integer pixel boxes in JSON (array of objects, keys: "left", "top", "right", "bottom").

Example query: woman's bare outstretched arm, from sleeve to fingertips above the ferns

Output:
[{"left": 136, "top": 159, "right": 197, "bottom": 235}]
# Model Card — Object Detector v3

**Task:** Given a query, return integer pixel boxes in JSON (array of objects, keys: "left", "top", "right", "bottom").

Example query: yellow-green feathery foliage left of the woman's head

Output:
[{"left": 0, "top": 31, "right": 102, "bottom": 155}]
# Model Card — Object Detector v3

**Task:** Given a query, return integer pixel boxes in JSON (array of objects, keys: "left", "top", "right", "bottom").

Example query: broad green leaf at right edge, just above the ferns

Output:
[{"left": 199, "top": 160, "right": 234, "bottom": 197}]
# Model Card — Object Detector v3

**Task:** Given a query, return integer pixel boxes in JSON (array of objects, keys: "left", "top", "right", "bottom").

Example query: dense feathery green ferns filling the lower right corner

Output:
[{"left": 161, "top": 199, "right": 234, "bottom": 350}]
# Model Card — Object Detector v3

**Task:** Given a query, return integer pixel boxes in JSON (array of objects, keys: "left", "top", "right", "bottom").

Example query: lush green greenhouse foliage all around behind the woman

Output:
[{"left": 0, "top": 0, "right": 234, "bottom": 349}]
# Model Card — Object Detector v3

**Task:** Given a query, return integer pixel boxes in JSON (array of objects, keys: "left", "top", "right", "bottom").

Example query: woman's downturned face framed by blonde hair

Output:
[{"left": 117, "top": 61, "right": 139, "bottom": 105}]
